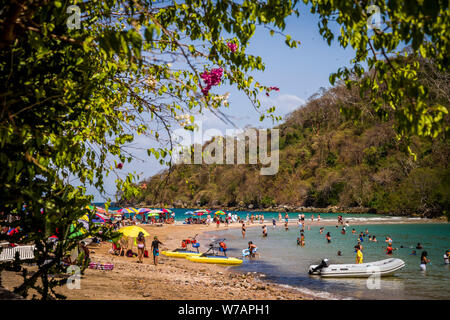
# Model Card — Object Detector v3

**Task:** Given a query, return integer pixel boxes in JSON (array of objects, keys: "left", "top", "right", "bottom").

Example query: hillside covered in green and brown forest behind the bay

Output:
[{"left": 131, "top": 57, "right": 450, "bottom": 217}]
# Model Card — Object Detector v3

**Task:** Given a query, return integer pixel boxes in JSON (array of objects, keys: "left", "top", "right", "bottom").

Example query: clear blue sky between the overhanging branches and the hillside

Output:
[{"left": 88, "top": 7, "right": 354, "bottom": 202}]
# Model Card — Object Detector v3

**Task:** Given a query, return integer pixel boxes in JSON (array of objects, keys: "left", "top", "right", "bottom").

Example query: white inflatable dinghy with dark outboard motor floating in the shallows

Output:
[{"left": 308, "top": 258, "right": 405, "bottom": 278}]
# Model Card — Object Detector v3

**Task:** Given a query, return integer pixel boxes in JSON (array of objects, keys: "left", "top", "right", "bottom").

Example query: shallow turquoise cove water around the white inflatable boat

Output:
[{"left": 201, "top": 223, "right": 450, "bottom": 300}]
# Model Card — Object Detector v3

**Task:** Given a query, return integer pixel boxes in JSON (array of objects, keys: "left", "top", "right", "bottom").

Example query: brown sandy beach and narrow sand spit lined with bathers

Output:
[{"left": 2, "top": 217, "right": 445, "bottom": 300}]
